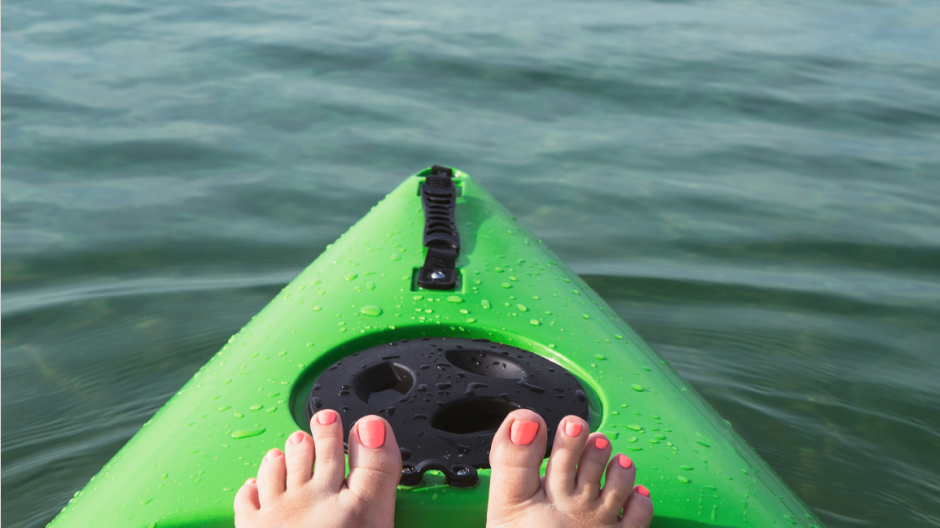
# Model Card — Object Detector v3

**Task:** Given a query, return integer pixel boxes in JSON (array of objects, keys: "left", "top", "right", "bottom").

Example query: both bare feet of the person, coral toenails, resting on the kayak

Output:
[{"left": 235, "top": 410, "right": 653, "bottom": 528}]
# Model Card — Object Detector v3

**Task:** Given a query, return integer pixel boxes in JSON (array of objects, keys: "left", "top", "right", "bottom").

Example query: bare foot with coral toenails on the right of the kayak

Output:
[{"left": 486, "top": 409, "right": 653, "bottom": 528}]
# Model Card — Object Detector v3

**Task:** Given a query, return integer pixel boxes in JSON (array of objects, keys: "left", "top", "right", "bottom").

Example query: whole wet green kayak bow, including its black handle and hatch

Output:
[{"left": 51, "top": 166, "right": 822, "bottom": 528}]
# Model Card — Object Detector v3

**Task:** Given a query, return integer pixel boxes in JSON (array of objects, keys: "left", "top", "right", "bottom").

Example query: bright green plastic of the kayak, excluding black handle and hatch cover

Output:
[{"left": 52, "top": 170, "right": 822, "bottom": 528}]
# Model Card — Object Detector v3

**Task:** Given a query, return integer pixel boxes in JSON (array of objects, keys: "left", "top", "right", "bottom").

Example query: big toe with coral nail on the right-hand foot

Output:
[{"left": 490, "top": 409, "right": 548, "bottom": 504}]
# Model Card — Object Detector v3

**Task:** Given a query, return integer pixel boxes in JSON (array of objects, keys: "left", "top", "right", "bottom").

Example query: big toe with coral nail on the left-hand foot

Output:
[{"left": 346, "top": 416, "right": 401, "bottom": 505}]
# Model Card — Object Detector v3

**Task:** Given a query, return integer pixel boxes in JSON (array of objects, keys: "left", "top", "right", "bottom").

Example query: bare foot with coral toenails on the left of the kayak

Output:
[{"left": 235, "top": 410, "right": 401, "bottom": 528}]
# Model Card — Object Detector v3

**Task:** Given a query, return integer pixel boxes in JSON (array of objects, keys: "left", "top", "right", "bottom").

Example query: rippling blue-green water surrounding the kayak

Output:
[{"left": 2, "top": 0, "right": 940, "bottom": 528}]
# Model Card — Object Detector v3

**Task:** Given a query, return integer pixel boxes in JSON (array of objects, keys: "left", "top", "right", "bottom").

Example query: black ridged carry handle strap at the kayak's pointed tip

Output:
[{"left": 418, "top": 165, "right": 460, "bottom": 290}]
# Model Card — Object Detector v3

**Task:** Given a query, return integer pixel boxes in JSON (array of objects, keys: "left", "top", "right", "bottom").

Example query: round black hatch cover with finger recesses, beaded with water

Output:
[{"left": 305, "top": 337, "right": 588, "bottom": 487}]
